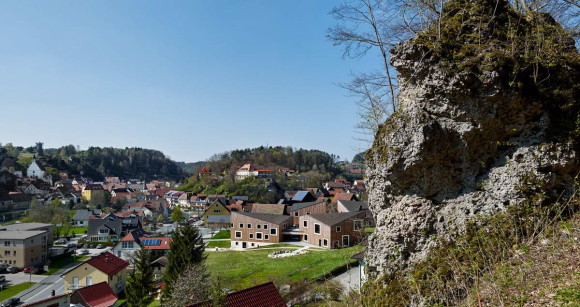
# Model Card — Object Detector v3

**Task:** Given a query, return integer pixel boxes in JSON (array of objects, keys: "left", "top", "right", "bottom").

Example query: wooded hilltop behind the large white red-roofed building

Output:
[{"left": 204, "top": 146, "right": 340, "bottom": 175}]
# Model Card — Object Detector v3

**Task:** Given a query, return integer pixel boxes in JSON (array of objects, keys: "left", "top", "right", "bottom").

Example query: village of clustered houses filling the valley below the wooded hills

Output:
[{"left": 0, "top": 158, "right": 374, "bottom": 306}]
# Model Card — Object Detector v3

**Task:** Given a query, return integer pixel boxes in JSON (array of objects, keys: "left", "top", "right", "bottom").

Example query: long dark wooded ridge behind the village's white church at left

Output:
[{"left": 0, "top": 143, "right": 184, "bottom": 180}]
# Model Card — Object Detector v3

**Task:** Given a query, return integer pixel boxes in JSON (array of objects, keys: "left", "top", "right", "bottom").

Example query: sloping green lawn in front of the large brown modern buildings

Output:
[{"left": 206, "top": 246, "right": 364, "bottom": 290}]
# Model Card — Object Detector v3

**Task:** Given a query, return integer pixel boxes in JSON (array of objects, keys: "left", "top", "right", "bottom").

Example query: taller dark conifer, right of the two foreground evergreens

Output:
[{"left": 163, "top": 225, "right": 205, "bottom": 299}]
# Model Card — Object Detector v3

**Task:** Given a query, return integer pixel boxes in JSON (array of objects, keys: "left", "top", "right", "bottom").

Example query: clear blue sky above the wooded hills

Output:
[{"left": 0, "top": 0, "right": 377, "bottom": 162}]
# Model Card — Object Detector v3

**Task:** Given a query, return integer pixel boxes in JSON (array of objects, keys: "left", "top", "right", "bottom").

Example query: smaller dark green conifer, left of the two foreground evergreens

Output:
[{"left": 125, "top": 248, "right": 155, "bottom": 307}]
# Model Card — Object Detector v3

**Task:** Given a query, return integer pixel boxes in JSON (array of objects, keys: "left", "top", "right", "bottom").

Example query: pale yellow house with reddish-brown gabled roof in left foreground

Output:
[{"left": 62, "top": 252, "right": 129, "bottom": 294}]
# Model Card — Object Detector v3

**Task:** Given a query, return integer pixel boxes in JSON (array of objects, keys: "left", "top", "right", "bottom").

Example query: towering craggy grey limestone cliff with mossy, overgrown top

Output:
[{"left": 366, "top": 0, "right": 580, "bottom": 276}]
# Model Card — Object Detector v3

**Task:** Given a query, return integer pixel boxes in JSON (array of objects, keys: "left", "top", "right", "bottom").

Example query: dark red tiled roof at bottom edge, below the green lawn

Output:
[{"left": 188, "top": 282, "right": 286, "bottom": 307}]
